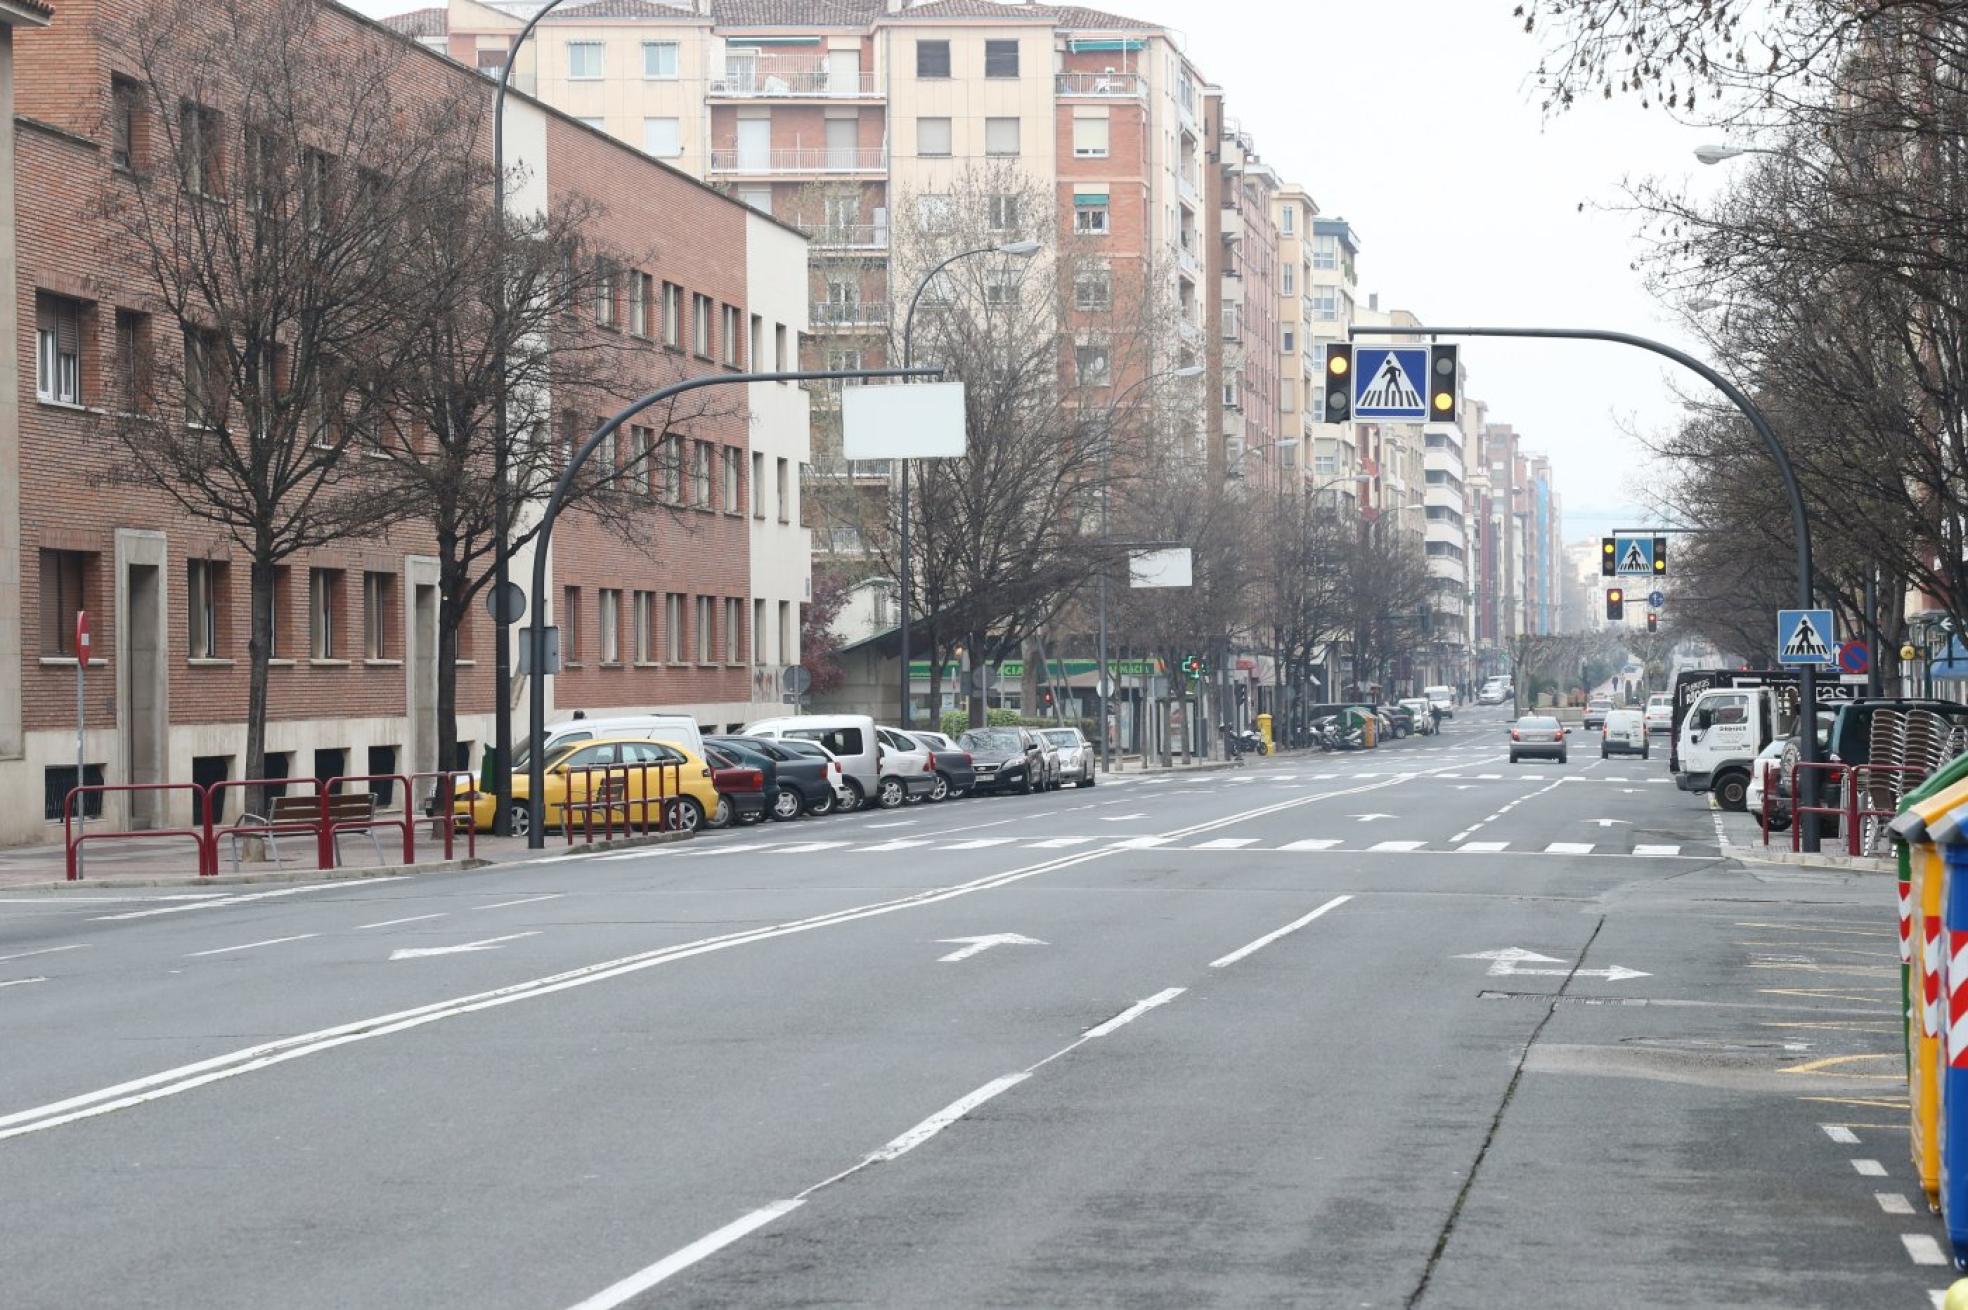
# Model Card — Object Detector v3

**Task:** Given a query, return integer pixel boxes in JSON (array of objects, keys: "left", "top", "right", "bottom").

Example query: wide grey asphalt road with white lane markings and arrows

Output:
[{"left": 0, "top": 710, "right": 1946, "bottom": 1310}]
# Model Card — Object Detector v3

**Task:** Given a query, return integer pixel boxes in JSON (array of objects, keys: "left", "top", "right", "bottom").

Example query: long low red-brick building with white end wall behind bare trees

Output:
[{"left": 0, "top": 0, "right": 807, "bottom": 842}]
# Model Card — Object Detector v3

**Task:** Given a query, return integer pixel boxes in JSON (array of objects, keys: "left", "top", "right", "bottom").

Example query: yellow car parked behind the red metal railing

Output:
[{"left": 457, "top": 738, "right": 718, "bottom": 836}]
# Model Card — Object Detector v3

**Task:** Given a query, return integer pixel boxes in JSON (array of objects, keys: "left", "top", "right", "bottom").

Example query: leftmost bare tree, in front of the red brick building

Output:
[{"left": 102, "top": 0, "right": 482, "bottom": 803}]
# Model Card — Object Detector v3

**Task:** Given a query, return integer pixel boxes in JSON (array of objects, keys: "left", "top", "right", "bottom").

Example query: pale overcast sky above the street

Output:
[{"left": 354, "top": 0, "right": 1728, "bottom": 541}]
